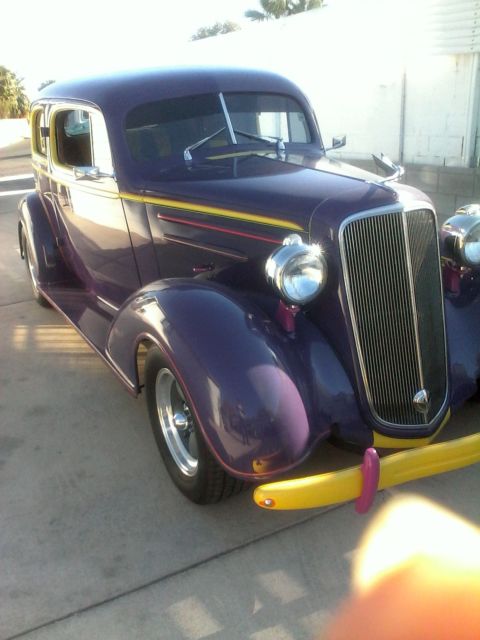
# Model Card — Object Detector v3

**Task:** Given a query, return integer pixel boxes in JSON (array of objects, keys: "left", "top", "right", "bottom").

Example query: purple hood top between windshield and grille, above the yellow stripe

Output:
[{"left": 142, "top": 153, "right": 398, "bottom": 238}]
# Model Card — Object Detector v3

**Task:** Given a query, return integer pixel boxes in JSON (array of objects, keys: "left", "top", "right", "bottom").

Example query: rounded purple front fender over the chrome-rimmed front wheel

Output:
[{"left": 107, "top": 279, "right": 360, "bottom": 478}]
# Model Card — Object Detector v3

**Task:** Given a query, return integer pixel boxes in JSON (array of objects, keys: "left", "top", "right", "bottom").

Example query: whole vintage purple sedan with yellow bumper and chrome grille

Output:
[{"left": 18, "top": 69, "right": 480, "bottom": 510}]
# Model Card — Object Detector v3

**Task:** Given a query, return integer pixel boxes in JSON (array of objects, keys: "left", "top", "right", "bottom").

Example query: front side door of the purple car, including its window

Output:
[{"left": 50, "top": 104, "right": 140, "bottom": 308}]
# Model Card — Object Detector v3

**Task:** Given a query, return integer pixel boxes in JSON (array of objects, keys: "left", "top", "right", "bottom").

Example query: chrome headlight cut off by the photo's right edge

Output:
[{"left": 443, "top": 204, "right": 480, "bottom": 267}]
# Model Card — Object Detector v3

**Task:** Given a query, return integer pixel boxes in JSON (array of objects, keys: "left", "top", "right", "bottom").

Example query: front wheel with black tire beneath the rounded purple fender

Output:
[{"left": 145, "top": 347, "right": 244, "bottom": 504}]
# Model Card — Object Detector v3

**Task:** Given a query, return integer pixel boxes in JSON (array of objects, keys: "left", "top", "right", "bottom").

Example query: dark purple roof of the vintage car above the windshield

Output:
[{"left": 36, "top": 67, "right": 305, "bottom": 114}]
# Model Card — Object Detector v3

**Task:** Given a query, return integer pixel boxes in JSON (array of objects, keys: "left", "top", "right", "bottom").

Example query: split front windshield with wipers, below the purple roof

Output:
[{"left": 125, "top": 93, "right": 311, "bottom": 168}]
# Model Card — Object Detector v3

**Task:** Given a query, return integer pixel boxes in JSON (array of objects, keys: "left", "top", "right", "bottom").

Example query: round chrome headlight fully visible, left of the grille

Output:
[{"left": 265, "top": 234, "right": 327, "bottom": 304}]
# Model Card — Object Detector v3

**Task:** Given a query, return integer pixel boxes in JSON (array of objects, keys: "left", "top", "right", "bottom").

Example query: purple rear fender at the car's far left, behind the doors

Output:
[{"left": 18, "top": 192, "right": 68, "bottom": 285}]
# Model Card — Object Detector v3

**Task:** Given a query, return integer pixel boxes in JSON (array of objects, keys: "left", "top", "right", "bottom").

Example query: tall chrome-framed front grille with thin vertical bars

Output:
[{"left": 341, "top": 209, "right": 447, "bottom": 427}]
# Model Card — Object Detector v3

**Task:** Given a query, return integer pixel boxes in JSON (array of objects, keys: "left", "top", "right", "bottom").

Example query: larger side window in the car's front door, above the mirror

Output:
[{"left": 55, "top": 109, "right": 93, "bottom": 167}]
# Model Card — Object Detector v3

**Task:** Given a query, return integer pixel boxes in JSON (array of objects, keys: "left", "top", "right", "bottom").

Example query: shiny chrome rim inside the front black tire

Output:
[{"left": 155, "top": 369, "right": 198, "bottom": 478}]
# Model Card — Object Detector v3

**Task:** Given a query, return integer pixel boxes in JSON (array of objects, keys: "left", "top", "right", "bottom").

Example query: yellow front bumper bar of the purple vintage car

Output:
[{"left": 253, "top": 433, "right": 480, "bottom": 510}]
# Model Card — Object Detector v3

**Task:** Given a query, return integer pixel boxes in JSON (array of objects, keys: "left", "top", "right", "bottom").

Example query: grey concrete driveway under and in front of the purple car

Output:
[{"left": 0, "top": 144, "right": 480, "bottom": 640}]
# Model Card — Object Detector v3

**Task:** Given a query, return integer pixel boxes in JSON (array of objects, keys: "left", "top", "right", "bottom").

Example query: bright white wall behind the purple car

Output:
[{"left": 165, "top": 0, "right": 478, "bottom": 171}]
